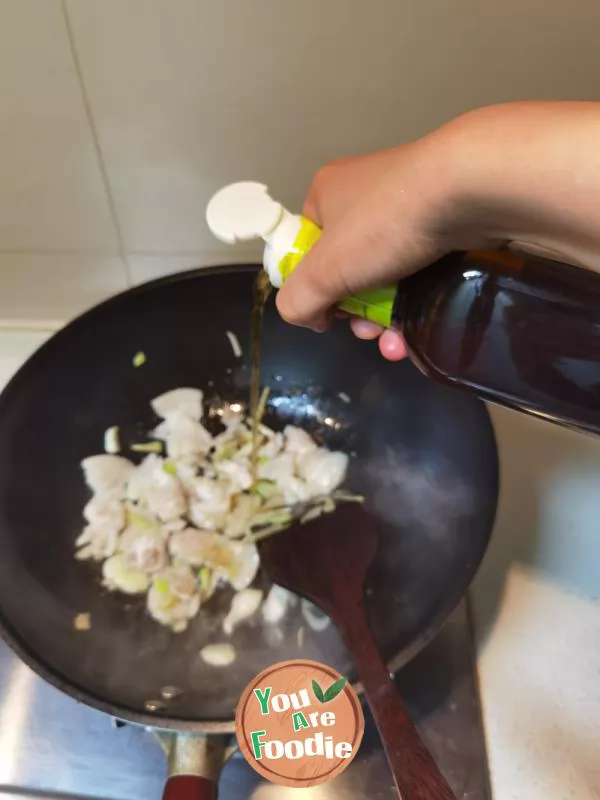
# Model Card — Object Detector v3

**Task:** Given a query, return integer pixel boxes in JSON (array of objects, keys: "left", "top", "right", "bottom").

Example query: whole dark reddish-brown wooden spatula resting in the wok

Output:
[{"left": 260, "top": 504, "right": 456, "bottom": 800}]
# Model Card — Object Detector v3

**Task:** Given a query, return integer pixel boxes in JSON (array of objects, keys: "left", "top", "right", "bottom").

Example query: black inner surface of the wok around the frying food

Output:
[{"left": 0, "top": 267, "right": 497, "bottom": 726}]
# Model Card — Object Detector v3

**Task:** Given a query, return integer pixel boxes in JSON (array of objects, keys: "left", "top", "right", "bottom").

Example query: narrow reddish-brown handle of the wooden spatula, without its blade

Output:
[{"left": 332, "top": 597, "right": 456, "bottom": 800}]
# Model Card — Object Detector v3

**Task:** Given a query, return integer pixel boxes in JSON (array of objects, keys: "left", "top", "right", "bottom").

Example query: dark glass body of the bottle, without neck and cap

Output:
[{"left": 393, "top": 250, "right": 600, "bottom": 433}]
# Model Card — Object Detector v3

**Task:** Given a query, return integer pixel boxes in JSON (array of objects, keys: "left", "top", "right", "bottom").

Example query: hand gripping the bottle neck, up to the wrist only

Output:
[{"left": 277, "top": 132, "right": 490, "bottom": 360}]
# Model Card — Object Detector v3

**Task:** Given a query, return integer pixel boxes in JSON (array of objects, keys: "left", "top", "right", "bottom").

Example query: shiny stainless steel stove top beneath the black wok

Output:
[{"left": 0, "top": 602, "right": 490, "bottom": 800}]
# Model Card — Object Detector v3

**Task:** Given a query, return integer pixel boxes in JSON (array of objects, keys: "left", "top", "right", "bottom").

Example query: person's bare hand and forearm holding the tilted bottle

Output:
[{"left": 277, "top": 103, "right": 600, "bottom": 360}]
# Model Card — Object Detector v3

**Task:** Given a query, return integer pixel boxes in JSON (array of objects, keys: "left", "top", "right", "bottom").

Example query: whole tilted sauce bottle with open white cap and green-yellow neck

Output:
[{"left": 207, "top": 183, "right": 600, "bottom": 434}]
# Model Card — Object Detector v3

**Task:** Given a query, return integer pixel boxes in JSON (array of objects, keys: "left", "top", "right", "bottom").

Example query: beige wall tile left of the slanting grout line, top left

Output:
[{"left": 0, "top": 0, "right": 117, "bottom": 252}]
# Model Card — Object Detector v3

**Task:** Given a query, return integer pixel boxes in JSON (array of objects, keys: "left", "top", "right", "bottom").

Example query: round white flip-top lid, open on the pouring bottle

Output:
[{"left": 206, "top": 181, "right": 284, "bottom": 244}]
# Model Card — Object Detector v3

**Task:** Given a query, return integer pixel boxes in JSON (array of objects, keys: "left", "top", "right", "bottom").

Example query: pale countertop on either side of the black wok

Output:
[{"left": 0, "top": 329, "right": 600, "bottom": 800}]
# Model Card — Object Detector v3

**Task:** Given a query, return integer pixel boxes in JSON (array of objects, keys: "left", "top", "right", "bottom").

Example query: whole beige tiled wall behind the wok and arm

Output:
[{"left": 0, "top": 0, "right": 600, "bottom": 322}]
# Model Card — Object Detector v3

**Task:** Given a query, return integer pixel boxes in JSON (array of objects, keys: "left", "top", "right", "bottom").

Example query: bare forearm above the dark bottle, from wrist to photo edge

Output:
[{"left": 436, "top": 103, "right": 600, "bottom": 271}]
